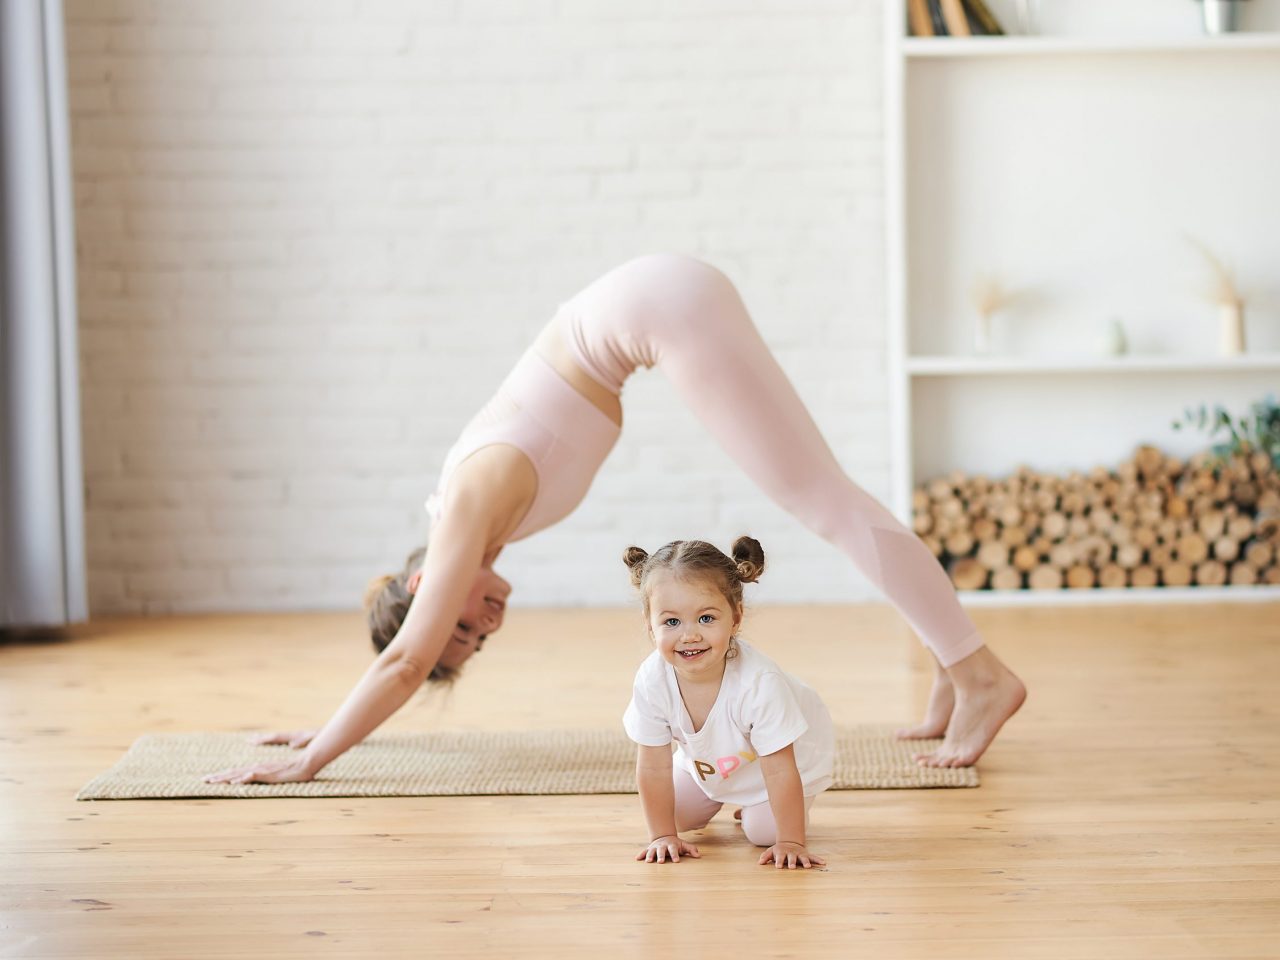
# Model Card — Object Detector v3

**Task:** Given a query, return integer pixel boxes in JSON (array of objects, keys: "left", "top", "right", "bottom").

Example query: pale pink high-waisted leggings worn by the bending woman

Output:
[{"left": 558, "top": 255, "right": 983, "bottom": 667}]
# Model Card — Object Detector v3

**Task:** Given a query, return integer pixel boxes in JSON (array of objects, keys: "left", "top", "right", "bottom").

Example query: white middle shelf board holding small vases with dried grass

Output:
[{"left": 906, "top": 353, "right": 1280, "bottom": 376}]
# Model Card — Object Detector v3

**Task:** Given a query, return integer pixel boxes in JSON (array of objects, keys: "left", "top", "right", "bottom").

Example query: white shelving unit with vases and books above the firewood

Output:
[{"left": 884, "top": 0, "right": 1280, "bottom": 603}]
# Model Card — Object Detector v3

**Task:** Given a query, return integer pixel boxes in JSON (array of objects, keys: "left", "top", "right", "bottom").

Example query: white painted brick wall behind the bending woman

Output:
[{"left": 67, "top": 0, "right": 887, "bottom": 614}]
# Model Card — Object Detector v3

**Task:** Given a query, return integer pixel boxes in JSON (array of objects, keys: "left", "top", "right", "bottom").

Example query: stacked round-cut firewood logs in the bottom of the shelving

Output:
[{"left": 913, "top": 447, "right": 1280, "bottom": 590}]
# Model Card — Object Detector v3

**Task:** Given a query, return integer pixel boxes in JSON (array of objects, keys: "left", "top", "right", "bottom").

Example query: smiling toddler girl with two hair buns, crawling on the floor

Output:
[{"left": 622, "top": 536, "right": 836, "bottom": 869}]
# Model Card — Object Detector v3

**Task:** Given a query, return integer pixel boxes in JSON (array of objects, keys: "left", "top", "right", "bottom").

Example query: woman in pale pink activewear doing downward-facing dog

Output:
[{"left": 206, "top": 255, "right": 1025, "bottom": 783}]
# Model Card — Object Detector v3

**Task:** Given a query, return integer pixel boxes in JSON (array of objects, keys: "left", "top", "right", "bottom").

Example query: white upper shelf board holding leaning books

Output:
[{"left": 902, "top": 33, "right": 1280, "bottom": 59}]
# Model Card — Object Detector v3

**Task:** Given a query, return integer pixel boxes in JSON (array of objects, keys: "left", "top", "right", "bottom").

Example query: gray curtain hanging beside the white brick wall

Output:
[{"left": 0, "top": 0, "right": 88, "bottom": 627}]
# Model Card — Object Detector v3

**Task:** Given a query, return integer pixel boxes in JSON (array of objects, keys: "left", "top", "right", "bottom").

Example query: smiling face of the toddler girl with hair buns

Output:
[{"left": 648, "top": 571, "right": 741, "bottom": 681}]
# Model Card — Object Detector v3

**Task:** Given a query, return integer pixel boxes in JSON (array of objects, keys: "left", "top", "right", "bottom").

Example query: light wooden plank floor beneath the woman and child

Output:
[{"left": 0, "top": 604, "right": 1280, "bottom": 960}]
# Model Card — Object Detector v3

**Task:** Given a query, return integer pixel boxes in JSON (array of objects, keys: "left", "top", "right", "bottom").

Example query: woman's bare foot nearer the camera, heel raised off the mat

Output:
[{"left": 915, "top": 646, "right": 1027, "bottom": 767}]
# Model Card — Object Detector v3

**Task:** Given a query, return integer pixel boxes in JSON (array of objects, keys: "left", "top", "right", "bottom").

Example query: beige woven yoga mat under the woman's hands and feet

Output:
[{"left": 76, "top": 726, "right": 978, "bottom": 800}]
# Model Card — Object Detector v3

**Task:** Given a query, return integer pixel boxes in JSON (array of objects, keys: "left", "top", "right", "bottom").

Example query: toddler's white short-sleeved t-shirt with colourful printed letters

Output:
[{"left": 622, "top": 640, "right": 836, "bottom": 806}]
